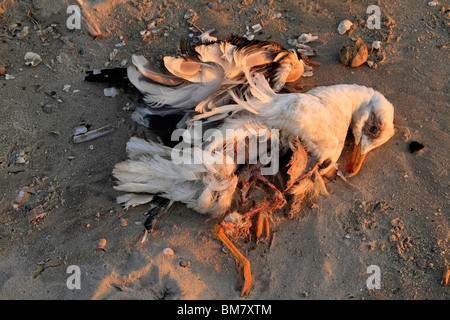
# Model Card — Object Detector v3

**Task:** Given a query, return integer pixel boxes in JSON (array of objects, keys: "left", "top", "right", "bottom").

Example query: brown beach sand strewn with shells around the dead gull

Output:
[{"left": 0, "top": 0, "right": 450, "bottom": 300}]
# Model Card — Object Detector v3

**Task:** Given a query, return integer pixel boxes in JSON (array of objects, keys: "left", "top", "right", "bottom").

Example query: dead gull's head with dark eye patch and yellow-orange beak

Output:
[{"left": 346, "top": 92, "right": 395, "bottom": 177}]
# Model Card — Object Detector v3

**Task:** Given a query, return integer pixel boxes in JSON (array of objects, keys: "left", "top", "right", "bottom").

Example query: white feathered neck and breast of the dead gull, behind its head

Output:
[{"left": 260, "top": 85, "right": 374, "bottom": 164}]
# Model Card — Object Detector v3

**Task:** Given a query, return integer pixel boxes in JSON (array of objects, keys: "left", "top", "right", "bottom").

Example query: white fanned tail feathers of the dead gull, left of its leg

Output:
[{"left": 113, "top": 138, "right": 237, "bottom": 215}]
